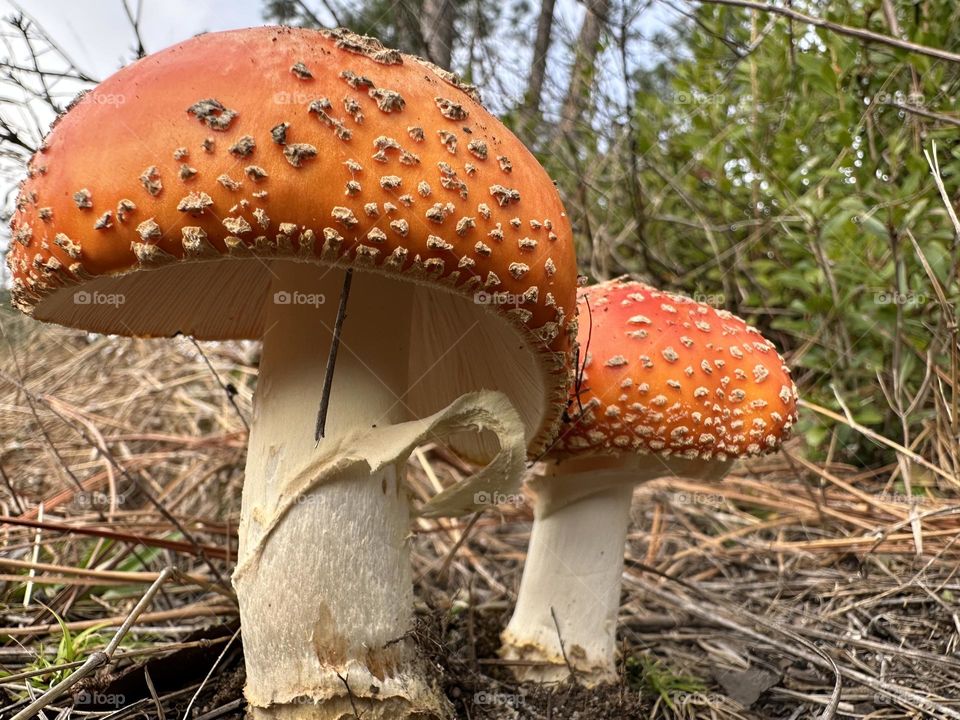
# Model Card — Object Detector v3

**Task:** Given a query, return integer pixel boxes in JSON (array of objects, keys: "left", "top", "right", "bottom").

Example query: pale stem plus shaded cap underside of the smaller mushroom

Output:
[{"left": 500, "top": 455, "right": 730, "bottom": 686}]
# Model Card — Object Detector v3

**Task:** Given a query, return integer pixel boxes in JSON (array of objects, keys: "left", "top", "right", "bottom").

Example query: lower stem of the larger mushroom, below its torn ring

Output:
[{"left": 234, "top": 467, "right": 450, "bottom": 720}]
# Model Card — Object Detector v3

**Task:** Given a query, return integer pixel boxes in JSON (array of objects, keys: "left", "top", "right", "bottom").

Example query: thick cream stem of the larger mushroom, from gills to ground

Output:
[{"left": 234, "top": 261, "right": 447, "bottom": 720}]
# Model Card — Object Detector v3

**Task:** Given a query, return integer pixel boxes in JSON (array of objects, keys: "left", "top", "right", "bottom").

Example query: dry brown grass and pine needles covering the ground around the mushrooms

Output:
[{"left": 0, "top": 311, "right": 960, "bottom": 720}]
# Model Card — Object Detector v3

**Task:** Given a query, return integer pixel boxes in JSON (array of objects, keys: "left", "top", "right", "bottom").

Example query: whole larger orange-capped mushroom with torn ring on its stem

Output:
[{"left": 8, "top": 28, "right": 576, "bottom": 720}]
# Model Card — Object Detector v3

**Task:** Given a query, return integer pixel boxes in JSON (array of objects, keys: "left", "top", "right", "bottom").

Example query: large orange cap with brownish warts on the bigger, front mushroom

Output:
[{"left": 7, "top": 27, "right": 576, "bottom": 456}]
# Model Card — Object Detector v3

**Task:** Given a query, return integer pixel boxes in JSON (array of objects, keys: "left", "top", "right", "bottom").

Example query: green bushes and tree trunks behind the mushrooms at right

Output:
[{"left": 267, "top": 0, "right": 960, "bottom": 478}]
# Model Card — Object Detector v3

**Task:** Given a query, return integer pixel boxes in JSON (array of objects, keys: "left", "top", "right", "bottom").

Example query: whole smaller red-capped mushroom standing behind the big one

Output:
[{"left": 501, "top": 279, "right": 797, "bottom": 684}]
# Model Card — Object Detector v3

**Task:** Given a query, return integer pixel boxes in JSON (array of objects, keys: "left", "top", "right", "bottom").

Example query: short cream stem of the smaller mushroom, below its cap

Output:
[{"left": 501, "top": 473, "right": 633, "bottom": 686}]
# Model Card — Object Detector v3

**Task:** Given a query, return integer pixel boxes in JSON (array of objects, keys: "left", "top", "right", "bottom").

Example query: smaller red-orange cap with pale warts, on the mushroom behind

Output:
[{"left": 551, "top": 279, "right": 797, "bottom": 460}]
